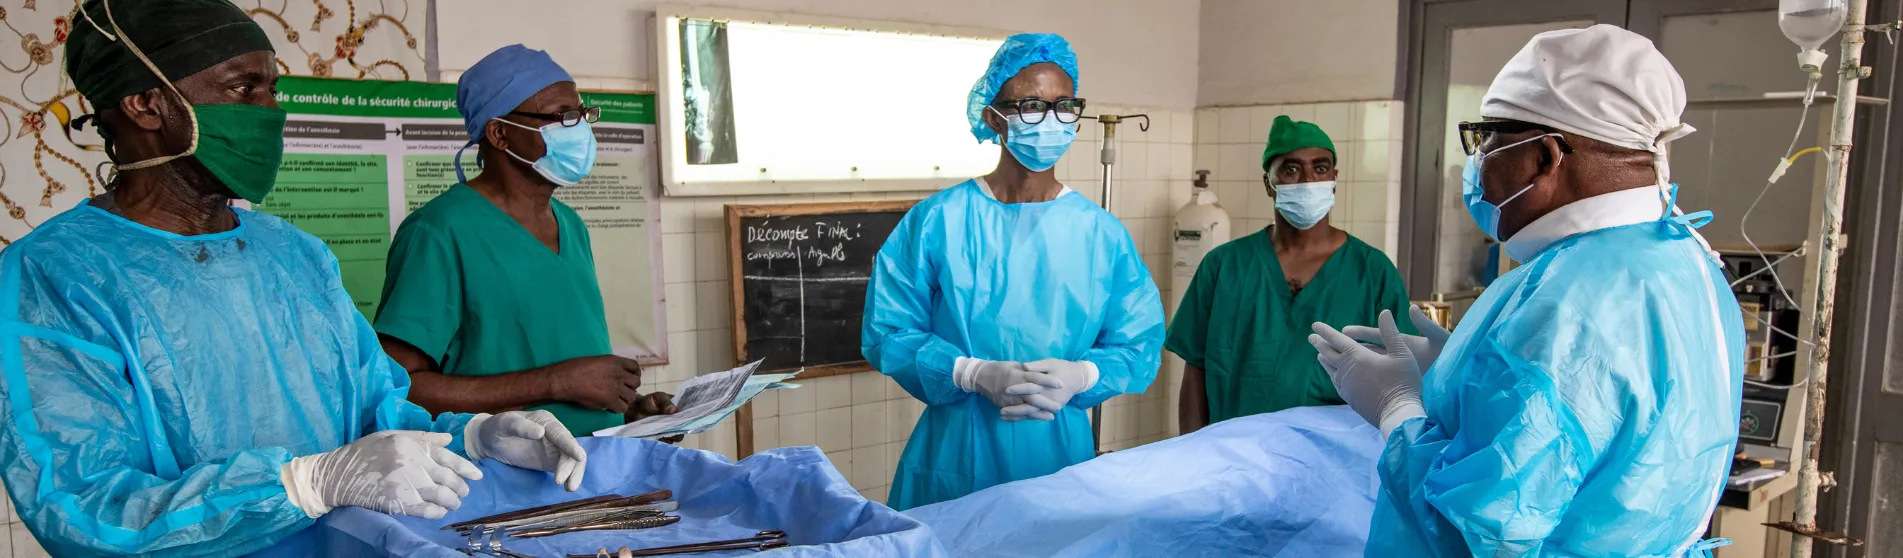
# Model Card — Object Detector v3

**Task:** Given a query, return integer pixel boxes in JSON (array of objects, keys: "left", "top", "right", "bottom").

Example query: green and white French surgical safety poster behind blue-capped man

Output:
[{"left": 255, "top": 76, "right": 668, "bottom": 364}]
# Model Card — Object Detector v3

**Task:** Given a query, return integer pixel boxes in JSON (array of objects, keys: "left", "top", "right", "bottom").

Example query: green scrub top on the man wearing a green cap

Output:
[{"left": 1163, "top": 229, "right": 1418, "bottom": 423}]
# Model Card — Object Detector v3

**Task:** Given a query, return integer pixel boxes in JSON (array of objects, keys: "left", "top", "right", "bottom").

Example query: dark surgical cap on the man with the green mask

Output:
[{"left": 67, "top": 0, "right": 272, "bottom": 110}]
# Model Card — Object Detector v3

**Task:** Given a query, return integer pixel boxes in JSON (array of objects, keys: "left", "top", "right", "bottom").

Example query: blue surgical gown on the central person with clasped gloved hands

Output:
[{"left": 860, "top": 181, "right": 1163, "bottom": 510}]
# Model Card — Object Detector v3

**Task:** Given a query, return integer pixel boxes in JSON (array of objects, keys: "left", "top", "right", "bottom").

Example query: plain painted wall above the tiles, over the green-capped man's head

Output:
[{"left": 1197, "top": 0, "right": 1401, "bottom": 107}]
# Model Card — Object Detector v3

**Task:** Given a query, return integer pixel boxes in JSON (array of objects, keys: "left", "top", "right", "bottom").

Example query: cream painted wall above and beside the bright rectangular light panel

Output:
[{"left": 438, "top": 0, "right": 1199, "bottom": 109}]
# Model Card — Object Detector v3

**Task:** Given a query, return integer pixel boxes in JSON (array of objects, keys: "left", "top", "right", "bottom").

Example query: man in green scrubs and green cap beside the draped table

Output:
[{"left": 1163, "top": 116, "right": 1416, "bottom": 434}]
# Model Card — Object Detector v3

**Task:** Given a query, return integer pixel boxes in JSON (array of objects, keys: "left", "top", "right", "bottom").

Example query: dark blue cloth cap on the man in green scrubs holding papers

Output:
[{"left": 457, "top": 44, "right": 575, "bottom": 181}]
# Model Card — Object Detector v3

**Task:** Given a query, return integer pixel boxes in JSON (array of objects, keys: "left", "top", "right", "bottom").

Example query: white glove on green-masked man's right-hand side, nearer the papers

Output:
[{"left": 462, "top": 411, "right": 588, "bottom": 491}]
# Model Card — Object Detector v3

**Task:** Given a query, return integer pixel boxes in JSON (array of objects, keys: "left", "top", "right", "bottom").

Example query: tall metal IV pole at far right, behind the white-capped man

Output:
[{"left": 1768, "top": 0, "right": 1895, "bottom": 548}]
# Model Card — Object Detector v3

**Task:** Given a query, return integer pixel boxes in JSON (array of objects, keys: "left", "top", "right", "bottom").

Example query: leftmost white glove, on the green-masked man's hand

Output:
[{"left": 278, "top": 430, "right": 481, "bottom": 520}]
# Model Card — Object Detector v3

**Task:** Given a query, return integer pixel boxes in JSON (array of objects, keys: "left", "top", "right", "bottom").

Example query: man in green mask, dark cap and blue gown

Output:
[{"left": 0, "top": 0, "right": 586, "bottom": 556}]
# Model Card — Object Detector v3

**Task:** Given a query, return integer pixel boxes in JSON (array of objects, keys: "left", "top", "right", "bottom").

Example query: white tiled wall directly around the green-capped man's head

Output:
[{"left": 1195, "top": 101, "right": 1403, "bottom": 257}]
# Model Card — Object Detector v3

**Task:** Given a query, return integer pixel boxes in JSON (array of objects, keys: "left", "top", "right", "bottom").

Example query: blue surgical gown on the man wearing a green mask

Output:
[{"left": 0, "top": 206, "right": 468, "bottom": 556}]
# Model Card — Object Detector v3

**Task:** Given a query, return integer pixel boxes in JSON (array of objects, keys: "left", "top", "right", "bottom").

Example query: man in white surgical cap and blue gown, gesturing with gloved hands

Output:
[{"left": 1309, "top": 25, "right": 1743, "bottom": 556}]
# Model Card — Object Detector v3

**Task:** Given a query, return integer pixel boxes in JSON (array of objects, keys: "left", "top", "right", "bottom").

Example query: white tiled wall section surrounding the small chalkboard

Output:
[{"left": 643, "top": 107, "right": 1195, "bottom": 501}]
